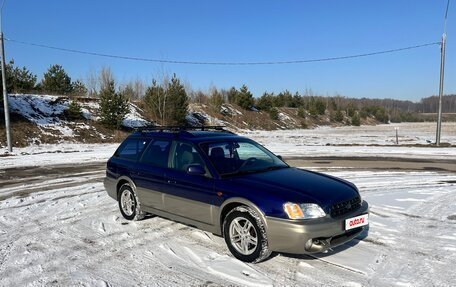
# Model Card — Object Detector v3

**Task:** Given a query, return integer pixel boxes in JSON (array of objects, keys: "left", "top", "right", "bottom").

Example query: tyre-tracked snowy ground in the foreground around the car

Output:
[{"left": 0, "top": 164, "right": 456, "bottom": 286}]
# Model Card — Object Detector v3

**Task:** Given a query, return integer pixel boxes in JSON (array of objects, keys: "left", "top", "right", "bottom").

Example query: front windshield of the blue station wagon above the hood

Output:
[{"left": 200, "top": 141, "right": 288, "bottom": 177}]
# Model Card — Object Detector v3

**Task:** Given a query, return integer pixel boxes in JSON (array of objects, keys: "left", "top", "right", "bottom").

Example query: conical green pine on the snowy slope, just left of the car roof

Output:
[{"left": 100, "top": 81, "right": 129, "bottom": 129}]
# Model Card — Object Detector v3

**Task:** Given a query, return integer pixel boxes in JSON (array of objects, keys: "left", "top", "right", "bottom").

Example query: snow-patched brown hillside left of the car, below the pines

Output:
[{"left": 0, "top": 94, "right": 147, "bottom": 146}]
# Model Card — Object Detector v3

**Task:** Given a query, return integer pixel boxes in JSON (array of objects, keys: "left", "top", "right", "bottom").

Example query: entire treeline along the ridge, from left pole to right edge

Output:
[{"left": 0, "top": 61, "right": 456, "bottom": 128}]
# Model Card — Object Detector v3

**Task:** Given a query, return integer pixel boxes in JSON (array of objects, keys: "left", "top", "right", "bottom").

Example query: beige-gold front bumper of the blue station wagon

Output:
[{"left": 266, "top": 201, "right": 369, "bottom": 254}]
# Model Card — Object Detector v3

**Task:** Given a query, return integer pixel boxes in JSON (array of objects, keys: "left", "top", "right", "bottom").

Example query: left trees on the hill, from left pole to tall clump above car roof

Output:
[{"left": 0, "top": 61, "right": 189, "bottom": 128}]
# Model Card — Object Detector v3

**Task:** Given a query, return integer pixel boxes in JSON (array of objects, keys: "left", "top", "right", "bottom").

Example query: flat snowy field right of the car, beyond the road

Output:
[{"left": 243, "top": 123, "right": 456, "bottom": 159}]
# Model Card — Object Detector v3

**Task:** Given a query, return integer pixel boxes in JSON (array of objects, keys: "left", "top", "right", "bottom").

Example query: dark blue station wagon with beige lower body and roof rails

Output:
[{"left": 104, "top": 127, "right": 369, "bottom": 262}]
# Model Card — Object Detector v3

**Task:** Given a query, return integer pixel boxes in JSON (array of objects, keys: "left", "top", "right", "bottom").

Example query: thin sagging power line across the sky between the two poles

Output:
[{"left": 5, "top": 38, "right": 441, "bottom": 66}]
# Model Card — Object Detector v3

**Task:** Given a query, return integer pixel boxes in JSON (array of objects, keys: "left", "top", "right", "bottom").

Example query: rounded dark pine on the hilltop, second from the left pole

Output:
[{"left": 41, "top": 65, "right": 73, "bottom": 95}]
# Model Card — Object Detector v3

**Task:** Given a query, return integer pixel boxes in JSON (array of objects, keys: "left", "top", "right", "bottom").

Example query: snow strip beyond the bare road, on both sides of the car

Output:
[{"left": 0, "top": 123, "right": 456, "bottom": 169}]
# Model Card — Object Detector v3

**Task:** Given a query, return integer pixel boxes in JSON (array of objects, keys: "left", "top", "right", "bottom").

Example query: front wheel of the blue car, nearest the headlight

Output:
[{"left": 223, "top": 206, "right": 271, "bottom": 263}]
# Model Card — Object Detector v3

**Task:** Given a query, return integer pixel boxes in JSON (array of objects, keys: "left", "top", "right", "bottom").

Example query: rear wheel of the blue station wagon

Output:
[{"left": 117, "top": 183, "right": 146, "bottom": 221}]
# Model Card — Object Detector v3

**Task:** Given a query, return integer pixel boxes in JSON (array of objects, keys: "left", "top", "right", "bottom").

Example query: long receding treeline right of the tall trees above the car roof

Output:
[{"left": 190, "top": 88, "right": 456, "bottom": 125}]
